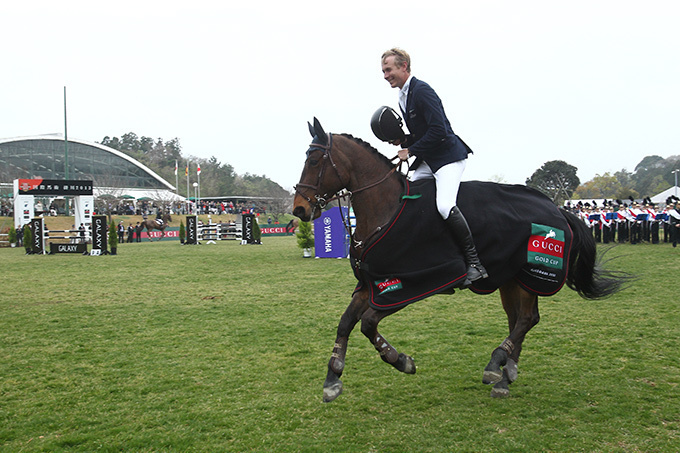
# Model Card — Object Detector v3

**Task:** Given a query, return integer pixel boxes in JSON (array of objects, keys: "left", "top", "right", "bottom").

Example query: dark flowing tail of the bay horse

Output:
[{"left": 560, "top": 209, "right": 632, "bottom": 299}]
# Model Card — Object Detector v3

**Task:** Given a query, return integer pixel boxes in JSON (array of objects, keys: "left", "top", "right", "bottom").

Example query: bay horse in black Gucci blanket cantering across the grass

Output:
[{"left": 293, "top": 118, "right": 628, "bottom": 402}]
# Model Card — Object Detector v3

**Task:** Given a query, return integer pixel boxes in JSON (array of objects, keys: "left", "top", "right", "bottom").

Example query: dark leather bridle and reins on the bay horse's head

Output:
[{"left": 295, "top": 133, "right": 408, "bottom": 218}]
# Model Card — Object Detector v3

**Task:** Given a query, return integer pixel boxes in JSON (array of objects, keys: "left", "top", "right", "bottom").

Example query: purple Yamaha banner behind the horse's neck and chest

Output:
[{"left": 314, "top": 207, "right": 349, "bottom": 258}]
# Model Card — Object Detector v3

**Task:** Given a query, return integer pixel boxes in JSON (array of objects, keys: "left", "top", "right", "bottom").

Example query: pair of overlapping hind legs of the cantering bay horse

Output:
[{"left": 482, "top": 282, "right": 540, "bottom": 397}]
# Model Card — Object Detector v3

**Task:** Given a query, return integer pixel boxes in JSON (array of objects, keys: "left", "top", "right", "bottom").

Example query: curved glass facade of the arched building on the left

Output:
[{"left": 0, "top": 137, "right": 172, "bottom": 189}]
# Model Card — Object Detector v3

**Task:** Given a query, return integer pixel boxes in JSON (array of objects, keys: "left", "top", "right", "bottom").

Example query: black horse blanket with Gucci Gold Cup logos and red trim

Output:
[{"left": 350, "top": 179, "right": 572, "bottom": 310}]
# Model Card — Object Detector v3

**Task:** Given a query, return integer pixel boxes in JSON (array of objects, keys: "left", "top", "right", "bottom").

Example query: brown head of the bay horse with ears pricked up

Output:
[{"left": 293, "top": 118, "right": 345, "bottom": 222}]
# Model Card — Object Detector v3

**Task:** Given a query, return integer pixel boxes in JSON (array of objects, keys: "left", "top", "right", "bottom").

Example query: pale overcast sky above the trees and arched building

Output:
[{"left": 0, "top": 0, "right": 680, "bottom": 193}]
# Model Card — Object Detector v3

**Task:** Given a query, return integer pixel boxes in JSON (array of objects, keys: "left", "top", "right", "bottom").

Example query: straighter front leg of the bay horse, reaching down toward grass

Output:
[{"left": 323, "top": 291, "right": 368, "bottom": 403}]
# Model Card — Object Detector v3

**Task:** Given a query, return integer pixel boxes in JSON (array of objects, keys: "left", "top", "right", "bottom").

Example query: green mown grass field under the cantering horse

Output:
[{"left": 0, "top": 237, "right": 680, "bottom": 452}]
